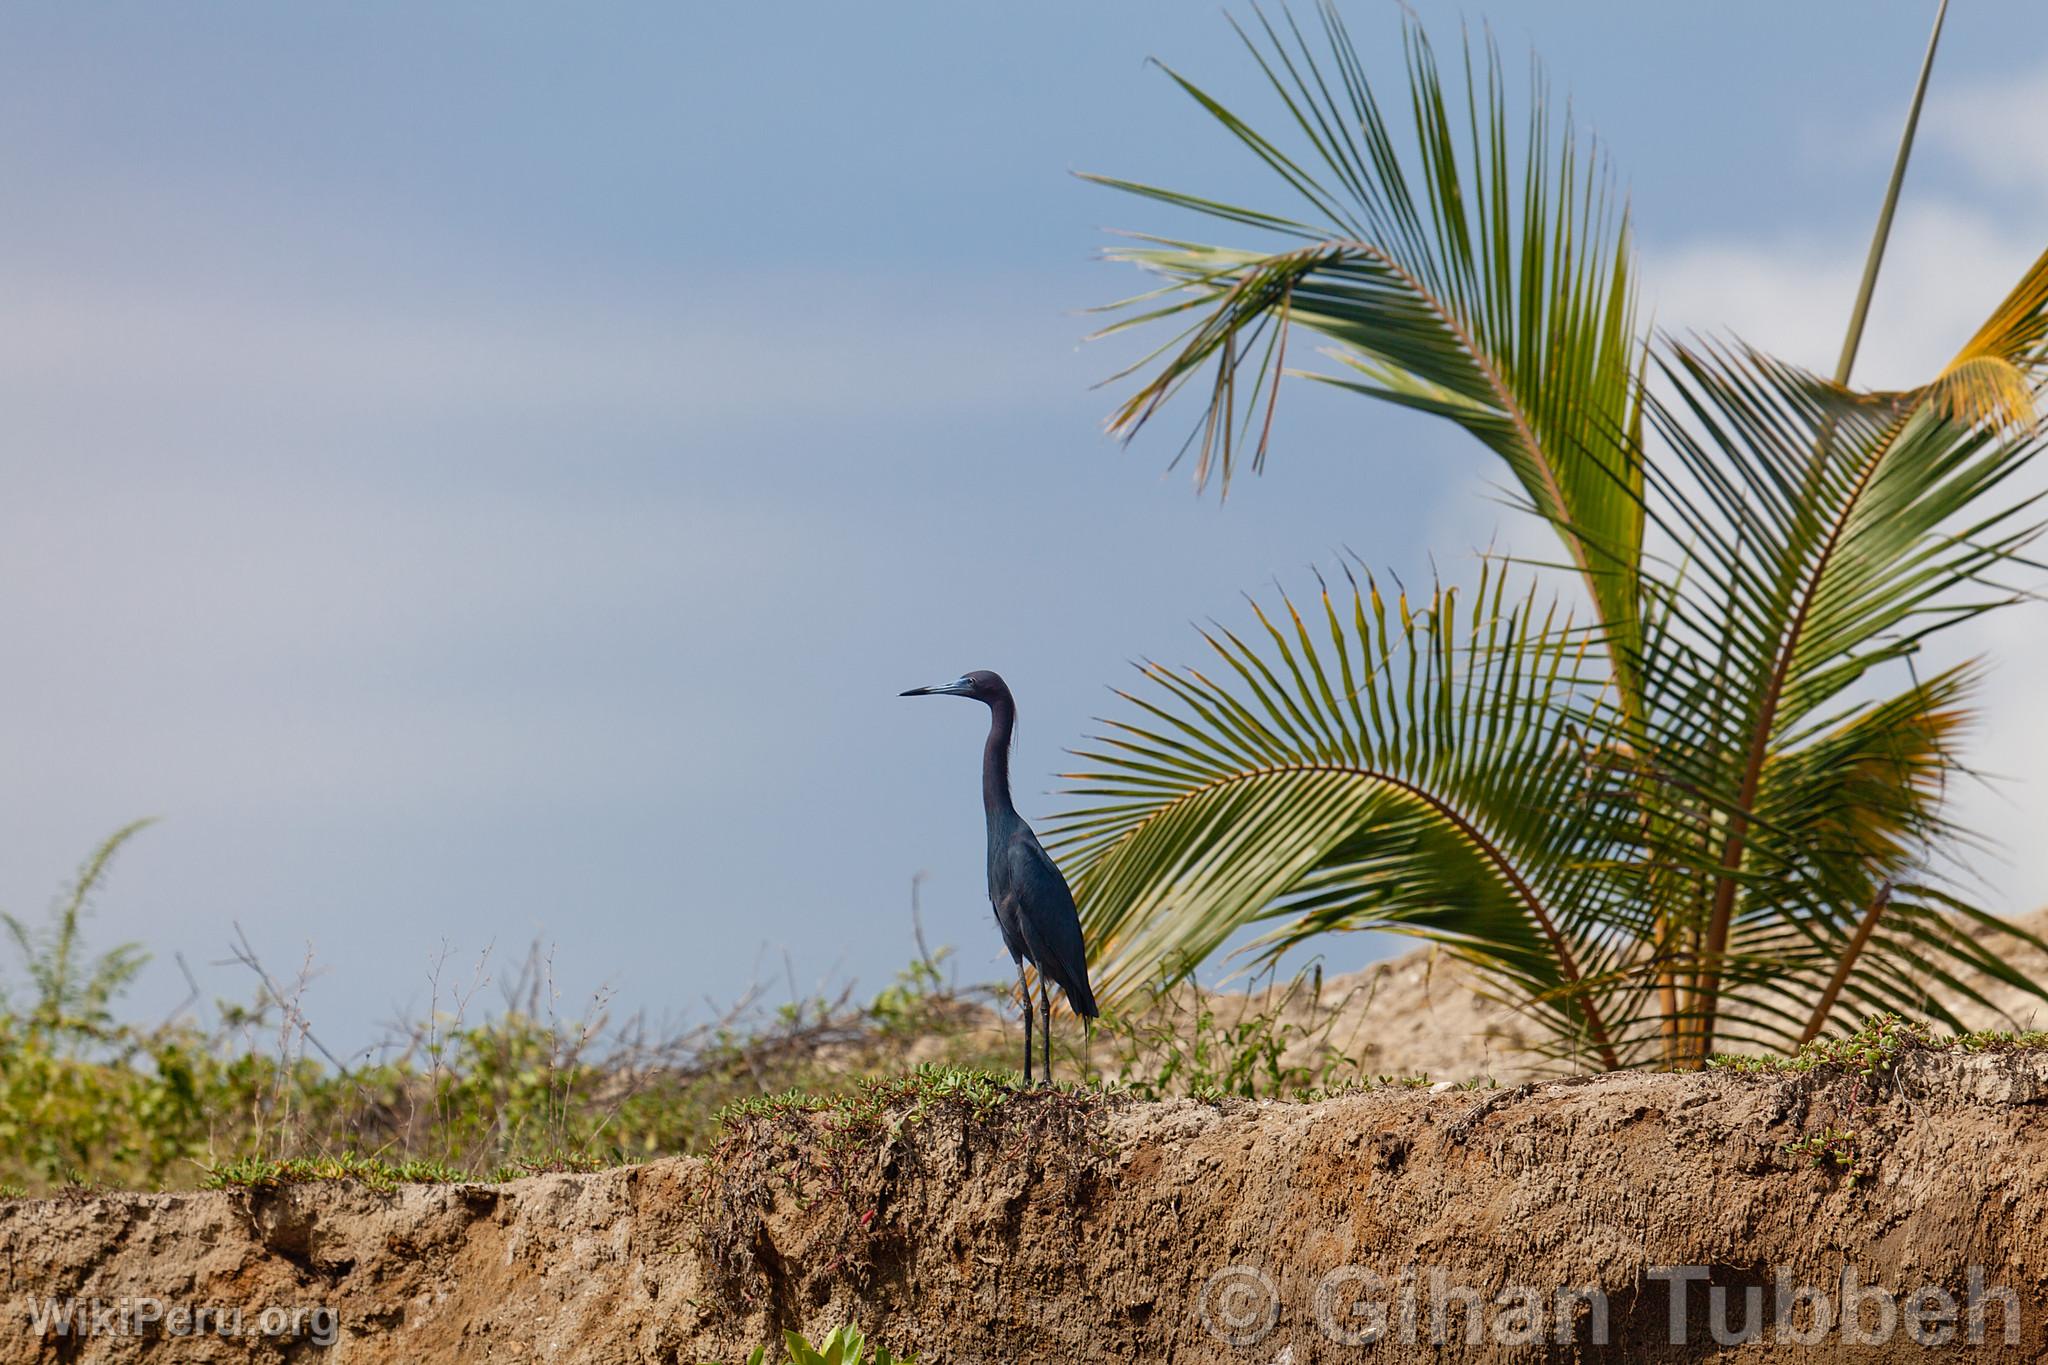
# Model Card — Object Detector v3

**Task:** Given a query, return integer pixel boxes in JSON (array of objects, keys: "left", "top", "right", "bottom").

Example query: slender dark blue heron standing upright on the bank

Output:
[{"left": 903, "top": 671, "right": 1096, "bottom": 1085}]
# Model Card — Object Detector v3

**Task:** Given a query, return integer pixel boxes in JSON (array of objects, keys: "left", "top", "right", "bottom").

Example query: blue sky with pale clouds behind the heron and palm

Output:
[{"left": 0, "top": 0, "right": 2048, "bottom": 1046}]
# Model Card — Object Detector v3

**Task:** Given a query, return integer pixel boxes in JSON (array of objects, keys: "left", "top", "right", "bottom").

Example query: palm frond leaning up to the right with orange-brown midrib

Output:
[{"left": 1638, "top": 346, "right": 2040, "bottom": 1054}]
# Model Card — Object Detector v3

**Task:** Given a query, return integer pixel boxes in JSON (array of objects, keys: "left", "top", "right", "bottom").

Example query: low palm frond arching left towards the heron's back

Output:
[{"left": 1053, "top": 565, "right": 1634, "bottom": 1066}]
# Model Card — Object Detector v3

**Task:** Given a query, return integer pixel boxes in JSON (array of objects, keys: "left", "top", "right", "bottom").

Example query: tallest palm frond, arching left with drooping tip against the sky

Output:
[{"left": 1092, "top": 4, "right": 1642, "bottom": 686}]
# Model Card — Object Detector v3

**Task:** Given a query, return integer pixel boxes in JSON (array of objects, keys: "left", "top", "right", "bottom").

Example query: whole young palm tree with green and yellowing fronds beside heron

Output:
[{"left": 1057, "top": 6, "right": 2048, "bottom": 1066}]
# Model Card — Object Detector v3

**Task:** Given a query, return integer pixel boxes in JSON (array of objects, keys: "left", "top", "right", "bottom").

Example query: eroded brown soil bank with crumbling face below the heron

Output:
[{"left": 0, "top": 1052, "right": 2048, "bottom": 1365}]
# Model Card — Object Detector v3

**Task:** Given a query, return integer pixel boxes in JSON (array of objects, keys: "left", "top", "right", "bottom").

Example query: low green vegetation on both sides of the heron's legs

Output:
[{"left": 0, "top": 825, "right": 1392, "bottom": 1197}]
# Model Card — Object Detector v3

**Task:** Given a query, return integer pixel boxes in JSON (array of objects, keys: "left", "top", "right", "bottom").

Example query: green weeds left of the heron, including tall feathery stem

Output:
[{"left": 0, "top": 825, "right": 999, "bottom": 1191}]
